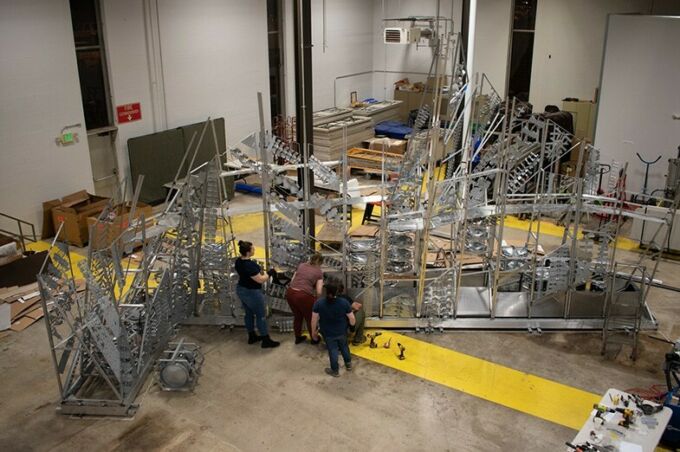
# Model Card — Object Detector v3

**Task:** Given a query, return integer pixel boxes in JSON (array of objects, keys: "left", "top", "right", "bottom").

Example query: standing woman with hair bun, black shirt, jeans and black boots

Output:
[{"left": 236, "top": 240, "right": 279, "bottom": 348}]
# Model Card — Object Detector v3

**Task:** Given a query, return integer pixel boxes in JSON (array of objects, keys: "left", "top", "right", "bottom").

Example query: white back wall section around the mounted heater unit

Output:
[{"left": 373, "top": 0, "right": 463, "bottom": 99}]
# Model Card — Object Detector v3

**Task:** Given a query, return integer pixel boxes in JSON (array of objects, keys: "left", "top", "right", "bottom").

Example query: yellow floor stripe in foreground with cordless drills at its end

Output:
[{"left": 352, "top": 331, "right": 601, "bottom": 430}]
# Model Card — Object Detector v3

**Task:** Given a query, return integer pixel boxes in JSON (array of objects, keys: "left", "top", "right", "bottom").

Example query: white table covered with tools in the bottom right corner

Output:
[{"left": 567, "top": 388, "right": 673, "bottom": 452}]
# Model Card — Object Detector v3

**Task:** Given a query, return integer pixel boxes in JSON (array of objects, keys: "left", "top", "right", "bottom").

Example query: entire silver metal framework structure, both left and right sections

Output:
[{"left": 38, "top": 22, "right": 678, "bottom": 416}]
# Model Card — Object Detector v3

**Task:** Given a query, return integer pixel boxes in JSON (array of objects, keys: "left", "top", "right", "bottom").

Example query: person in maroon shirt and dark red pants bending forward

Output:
[{"left": 286, "top": 253, "right": 323, "bottom": 344}]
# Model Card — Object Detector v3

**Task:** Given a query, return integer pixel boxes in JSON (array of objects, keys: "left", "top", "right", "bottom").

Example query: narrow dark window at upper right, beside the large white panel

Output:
[{"left": 508, "top": 0, "right": 537, "bottom": 102}]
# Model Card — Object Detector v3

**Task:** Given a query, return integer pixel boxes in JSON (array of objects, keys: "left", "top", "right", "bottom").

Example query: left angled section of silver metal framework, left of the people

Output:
[{"left": 38, "top": 121, "right": 242, "bottom": 416}]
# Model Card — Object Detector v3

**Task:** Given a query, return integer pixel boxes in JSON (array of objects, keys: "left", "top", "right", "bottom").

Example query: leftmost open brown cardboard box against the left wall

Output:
[{"left": 52, "top": 190, "right": 109, "bottom": 247}]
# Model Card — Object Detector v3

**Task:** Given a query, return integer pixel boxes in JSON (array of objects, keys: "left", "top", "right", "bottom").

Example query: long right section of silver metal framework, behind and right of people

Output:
[{"left": 231, "top": 29, "right": 677, "bottom": 331}]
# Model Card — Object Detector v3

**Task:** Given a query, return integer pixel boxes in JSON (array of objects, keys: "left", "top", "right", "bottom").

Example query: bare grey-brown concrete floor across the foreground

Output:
[{"left": 0, "top": 191, "right": 680, "bottom": 451}]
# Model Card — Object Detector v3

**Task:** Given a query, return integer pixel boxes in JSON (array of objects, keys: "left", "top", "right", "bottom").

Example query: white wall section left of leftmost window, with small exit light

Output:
[{"left": 0, "top": 0, "right": 93, "bottom": 230}]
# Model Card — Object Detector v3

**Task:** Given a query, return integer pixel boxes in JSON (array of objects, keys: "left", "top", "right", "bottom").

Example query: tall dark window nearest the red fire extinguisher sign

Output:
[{"left": 70, "top": 0, "right": 112, "bottom": 130}]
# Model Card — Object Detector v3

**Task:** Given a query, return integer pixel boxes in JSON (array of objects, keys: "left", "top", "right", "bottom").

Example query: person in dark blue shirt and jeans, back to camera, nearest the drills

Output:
[{"left": 311, "top": 279, "right": 356, "bottom": 377}]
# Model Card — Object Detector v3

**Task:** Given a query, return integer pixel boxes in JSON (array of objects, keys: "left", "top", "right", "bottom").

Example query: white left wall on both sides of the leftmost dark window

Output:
[{"left": 0, "top": 0, "right": 270, "bottom": 233}]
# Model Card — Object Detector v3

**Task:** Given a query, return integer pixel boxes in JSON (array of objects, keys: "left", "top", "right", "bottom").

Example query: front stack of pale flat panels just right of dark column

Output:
[{"left": 314, "top": 116, "right": 374, "bottom": 161}]
